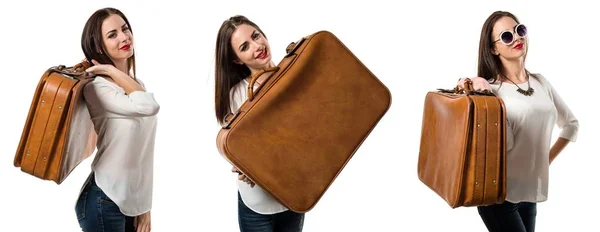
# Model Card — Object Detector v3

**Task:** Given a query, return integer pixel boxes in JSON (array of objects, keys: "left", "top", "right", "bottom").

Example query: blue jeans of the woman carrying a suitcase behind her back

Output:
[{"left": 75, "top": 174, "right": 135, "bottom": 232}]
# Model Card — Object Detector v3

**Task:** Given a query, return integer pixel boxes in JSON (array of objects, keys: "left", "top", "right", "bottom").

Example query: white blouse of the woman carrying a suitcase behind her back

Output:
[{"left": 83, "top": 76, "right": 160, "bottom": 216}]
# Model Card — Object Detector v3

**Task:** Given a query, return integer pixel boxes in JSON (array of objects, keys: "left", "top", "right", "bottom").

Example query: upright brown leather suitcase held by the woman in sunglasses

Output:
[{"left": 418, "top": 80, "right": 506, "bottom": 208}]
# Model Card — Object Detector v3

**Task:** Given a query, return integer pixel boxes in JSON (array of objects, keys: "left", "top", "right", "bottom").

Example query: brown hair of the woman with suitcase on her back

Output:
[{"left": 81, "top": 7, "right": 135, "bottom": 78}]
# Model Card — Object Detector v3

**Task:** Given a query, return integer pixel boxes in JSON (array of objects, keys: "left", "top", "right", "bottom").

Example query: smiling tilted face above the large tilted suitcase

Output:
[{"left": 231, "top": 24, "right": 271, "bottom": 73}]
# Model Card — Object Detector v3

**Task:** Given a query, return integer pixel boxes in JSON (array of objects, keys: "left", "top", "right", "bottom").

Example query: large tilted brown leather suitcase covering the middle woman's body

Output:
[{"left": 217, "top": 31, "right": 391, "bottom": 212}]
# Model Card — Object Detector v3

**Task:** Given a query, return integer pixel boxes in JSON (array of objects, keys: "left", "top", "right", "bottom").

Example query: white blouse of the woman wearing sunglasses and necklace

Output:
[{"left": 491, "top": 74, "right": 579, "bottom": 203}]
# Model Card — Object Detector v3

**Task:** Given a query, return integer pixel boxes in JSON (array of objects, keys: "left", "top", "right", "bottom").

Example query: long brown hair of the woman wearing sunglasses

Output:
[{"left": 477, "top": 11, "right": 529, "bottom": 83}]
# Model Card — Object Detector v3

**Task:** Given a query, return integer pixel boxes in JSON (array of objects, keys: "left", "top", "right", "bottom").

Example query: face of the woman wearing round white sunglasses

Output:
[{"left": 490, "top": 17, "right": 528, "bottom": 60}]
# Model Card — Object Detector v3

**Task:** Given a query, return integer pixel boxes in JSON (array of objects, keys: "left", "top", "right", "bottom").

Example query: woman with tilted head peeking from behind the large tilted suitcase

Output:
[{"left": 215, "top": 15, "right": 304, "bottom": 232}]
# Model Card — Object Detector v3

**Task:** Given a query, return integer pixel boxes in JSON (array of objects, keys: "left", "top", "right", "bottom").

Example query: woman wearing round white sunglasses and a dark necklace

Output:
[{"left": 458, "top": 11, "right": 579, "bottom": 232}]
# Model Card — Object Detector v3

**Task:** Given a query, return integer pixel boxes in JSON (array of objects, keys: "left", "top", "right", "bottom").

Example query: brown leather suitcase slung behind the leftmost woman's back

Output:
[{"left": 14, "top": 61, "right": 96, "bottom": 184}]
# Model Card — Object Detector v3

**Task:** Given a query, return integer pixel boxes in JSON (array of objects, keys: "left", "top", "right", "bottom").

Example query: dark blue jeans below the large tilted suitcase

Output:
[{"left": 238, "top": 192, "right": 304, "bottom": 232}]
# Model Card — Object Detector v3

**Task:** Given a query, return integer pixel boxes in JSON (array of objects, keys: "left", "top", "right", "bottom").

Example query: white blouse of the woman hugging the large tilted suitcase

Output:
[{"left": 229, "top": 79, "right": 288, "bottom": 214}]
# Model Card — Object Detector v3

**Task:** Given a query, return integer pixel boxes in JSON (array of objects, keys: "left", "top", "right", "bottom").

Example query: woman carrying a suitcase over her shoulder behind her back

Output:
[{"left": 75, "top": 8, "right": 160, "bottom": 232}]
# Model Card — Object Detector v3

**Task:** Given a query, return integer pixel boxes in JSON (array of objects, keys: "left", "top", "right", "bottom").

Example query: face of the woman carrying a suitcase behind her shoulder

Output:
[{"left": 102, "top": 14, "right": 133, "bottom": 63}]
